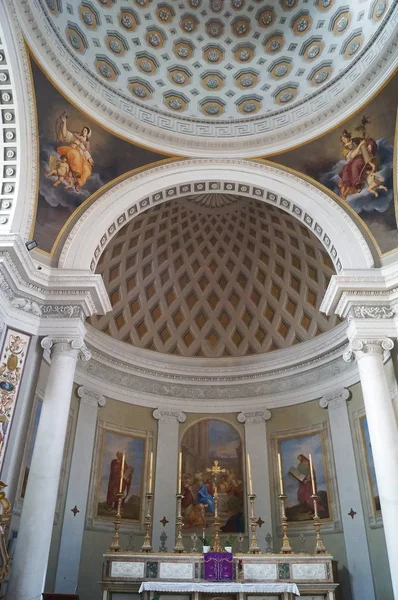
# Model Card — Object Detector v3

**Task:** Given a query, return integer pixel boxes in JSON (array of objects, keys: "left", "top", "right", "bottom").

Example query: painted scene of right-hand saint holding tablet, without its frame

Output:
[{"left": 279, "top": 433, "right": 330, "bottom": 522}]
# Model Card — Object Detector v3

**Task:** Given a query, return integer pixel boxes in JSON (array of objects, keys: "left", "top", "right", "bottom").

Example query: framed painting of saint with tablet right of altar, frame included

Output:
[{"left": 271, "top": 422, "right": 341, "bottom": 534}]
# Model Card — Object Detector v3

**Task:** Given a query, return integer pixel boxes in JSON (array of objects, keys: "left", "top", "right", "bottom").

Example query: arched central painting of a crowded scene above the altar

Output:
[{"left": 181, "top": 419, "right": 245, "bottom": 537}]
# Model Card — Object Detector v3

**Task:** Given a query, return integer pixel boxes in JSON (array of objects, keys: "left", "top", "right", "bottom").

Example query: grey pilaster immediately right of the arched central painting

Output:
[{"left": 237, "top": 409, "right": 272, "bottom": 552}]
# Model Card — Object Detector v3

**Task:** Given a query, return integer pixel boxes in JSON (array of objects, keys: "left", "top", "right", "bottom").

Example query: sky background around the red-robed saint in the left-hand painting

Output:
[{"left": 98, "top": 431, "right": 145, "bottom": 502}]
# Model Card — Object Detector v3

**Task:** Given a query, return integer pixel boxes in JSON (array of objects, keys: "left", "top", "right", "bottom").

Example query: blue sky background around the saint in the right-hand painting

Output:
[{"left": 279, "top": 433, "right": 327, "bottom": 506}]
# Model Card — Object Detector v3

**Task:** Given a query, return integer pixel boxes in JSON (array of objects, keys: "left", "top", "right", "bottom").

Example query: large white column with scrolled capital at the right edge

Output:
[{"left": 344, "top": 338, "right": 398, "bottom": 600}]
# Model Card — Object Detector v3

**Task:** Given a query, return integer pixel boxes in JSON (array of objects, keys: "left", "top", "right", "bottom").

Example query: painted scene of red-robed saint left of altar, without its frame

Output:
[{"left": 95, "top": 430, "right": 146, "bottom": 521}]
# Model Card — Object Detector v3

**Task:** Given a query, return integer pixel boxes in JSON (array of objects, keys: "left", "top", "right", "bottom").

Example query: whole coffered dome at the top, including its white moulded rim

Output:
[{"left": 19, "top": 0, "right": 395, "bottom": 153}]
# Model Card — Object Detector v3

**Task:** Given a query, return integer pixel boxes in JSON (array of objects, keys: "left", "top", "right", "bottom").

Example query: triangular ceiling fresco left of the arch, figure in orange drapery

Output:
[{"left": 31, "top": 61, "right": 166, "bottom": 253}]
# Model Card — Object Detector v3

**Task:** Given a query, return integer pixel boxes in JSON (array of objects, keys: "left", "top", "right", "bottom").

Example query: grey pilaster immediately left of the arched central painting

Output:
[{"left": 152, "top": 408, "right": 187, "bottom": 552}]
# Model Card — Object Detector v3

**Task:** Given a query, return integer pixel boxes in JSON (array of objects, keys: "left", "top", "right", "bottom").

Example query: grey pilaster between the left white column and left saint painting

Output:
[{"left": 55, "top": 386, "right": 105, "bottom": 594}]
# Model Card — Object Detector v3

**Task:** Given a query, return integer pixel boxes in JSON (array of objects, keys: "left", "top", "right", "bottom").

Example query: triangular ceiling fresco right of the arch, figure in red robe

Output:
[{"left": 270, "top": 76, "right": 398, "bottom": 253}]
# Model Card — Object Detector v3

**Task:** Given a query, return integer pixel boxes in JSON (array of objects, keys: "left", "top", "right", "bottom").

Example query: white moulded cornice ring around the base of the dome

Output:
[{"left": 13, "top": 0, "right": 398, "bottom": 156}]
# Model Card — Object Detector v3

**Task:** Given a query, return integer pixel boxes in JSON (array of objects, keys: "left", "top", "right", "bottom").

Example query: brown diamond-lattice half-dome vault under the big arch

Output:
[{"left": 91, "top": 196, "right": 338, "bottom": 358}]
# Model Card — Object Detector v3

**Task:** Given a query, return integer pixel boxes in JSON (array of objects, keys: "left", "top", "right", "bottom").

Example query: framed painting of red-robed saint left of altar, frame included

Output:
[{"left": 87, "top": 421, "right": 152, "bottom": 531}]
